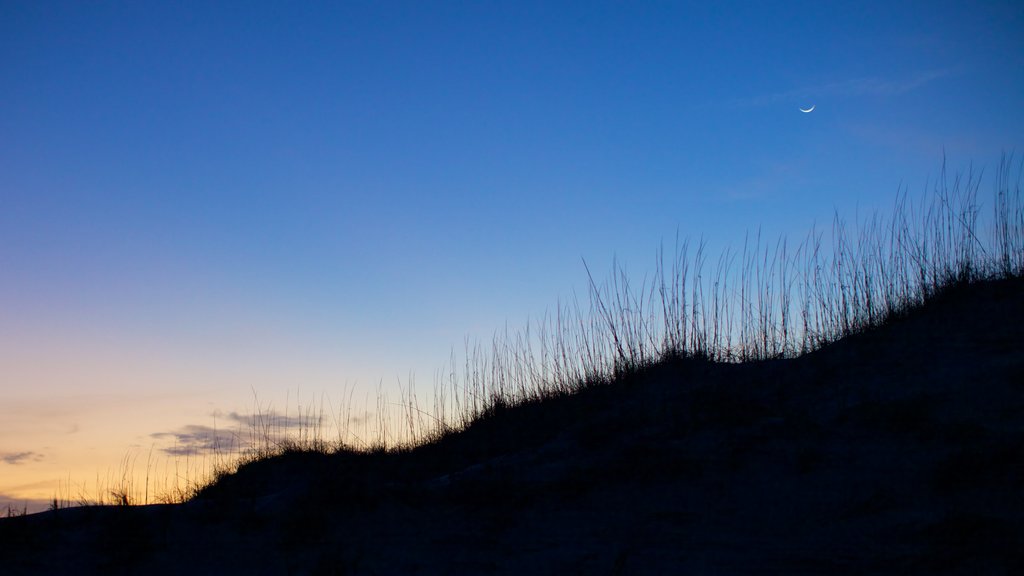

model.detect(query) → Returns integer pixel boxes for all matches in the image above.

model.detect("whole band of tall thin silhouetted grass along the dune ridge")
[44,157,1024,506]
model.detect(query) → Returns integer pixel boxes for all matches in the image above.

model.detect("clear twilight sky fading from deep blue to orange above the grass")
[0,0,1024,509]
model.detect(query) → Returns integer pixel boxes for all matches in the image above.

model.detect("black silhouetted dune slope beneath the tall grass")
[0,280,1024,575]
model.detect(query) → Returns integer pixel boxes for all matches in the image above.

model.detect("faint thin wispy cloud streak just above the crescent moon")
[732,69,954,107]
